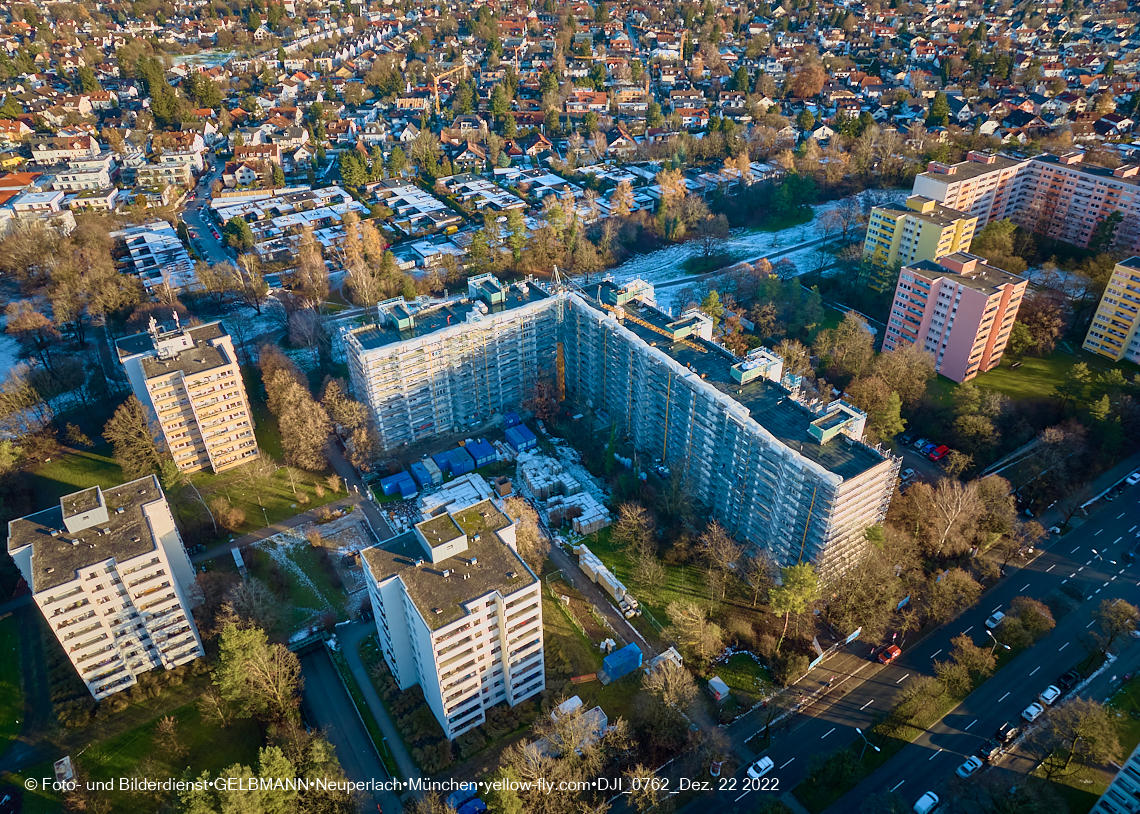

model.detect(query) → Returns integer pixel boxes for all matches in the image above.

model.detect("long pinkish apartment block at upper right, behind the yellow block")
[913,150,1140,252]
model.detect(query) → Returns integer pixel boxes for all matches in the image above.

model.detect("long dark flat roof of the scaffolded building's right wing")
[592,300,885,480]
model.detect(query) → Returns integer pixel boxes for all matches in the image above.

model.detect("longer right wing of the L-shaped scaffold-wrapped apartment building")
[561,283,899,581]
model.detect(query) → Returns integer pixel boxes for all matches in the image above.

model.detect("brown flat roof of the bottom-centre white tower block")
[360,500,528,630]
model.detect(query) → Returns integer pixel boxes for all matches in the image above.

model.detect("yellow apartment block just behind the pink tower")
[863,195,978,285]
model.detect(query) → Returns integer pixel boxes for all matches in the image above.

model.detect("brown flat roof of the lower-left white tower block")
[8,477,165,594]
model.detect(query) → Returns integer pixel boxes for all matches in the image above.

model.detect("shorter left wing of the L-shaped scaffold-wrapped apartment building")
[343,274,557,449]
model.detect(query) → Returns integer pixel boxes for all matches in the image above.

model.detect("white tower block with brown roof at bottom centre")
[361,500,546,738]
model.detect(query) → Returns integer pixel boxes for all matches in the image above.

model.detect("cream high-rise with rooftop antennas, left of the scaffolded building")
[115,315,258,472]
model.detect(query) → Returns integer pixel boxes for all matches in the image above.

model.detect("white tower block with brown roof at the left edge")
[8,475,203,700]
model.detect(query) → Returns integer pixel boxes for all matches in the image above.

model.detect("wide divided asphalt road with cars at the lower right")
[686,476,1140,814]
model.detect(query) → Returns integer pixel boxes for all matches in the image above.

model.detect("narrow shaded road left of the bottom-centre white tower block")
[301,648,402,812]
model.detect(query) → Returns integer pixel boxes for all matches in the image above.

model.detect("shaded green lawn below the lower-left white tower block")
[78,703,262,812]
